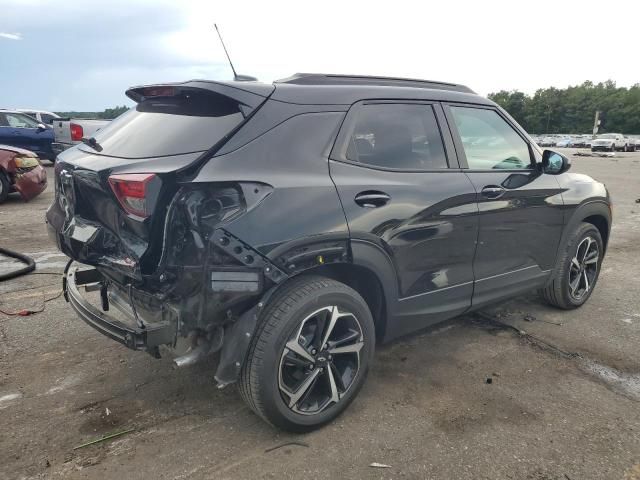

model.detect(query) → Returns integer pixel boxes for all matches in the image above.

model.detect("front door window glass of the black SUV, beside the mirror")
[451,106,531,170]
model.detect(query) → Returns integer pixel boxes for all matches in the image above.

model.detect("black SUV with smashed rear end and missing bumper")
[47,74,611,431]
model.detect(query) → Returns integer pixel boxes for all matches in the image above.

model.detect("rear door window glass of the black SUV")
[344,103,448,170]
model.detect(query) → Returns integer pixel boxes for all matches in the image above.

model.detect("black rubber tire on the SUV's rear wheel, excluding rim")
[239,276,375,432]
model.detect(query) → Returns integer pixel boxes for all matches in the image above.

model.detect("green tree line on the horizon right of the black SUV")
[489,80,640,134]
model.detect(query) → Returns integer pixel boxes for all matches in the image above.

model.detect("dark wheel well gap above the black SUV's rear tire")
[294,263,387,341]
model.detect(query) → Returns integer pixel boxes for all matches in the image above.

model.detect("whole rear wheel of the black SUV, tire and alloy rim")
[239,276,375,432]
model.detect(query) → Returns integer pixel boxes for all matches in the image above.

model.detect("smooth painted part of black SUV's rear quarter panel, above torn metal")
[194,112,348,257]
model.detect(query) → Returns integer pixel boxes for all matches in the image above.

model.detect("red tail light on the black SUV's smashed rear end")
[109,173,160,218]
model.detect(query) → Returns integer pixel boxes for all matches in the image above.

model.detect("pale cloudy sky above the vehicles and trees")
[0,0,640,111]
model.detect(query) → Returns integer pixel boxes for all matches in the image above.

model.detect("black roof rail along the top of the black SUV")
[273,73,476,93]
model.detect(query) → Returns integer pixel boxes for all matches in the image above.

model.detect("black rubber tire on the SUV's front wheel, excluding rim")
[540,223,604,310]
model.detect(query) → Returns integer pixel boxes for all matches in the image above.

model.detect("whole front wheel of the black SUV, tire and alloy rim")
[540,223,604,310]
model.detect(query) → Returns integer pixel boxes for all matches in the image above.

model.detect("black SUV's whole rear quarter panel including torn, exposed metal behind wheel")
[159,112,348,333]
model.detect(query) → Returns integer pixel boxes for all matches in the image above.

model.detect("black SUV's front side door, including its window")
[445,104,564,306]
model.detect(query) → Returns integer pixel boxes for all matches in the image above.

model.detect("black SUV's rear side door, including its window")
[329,101,478,339]
